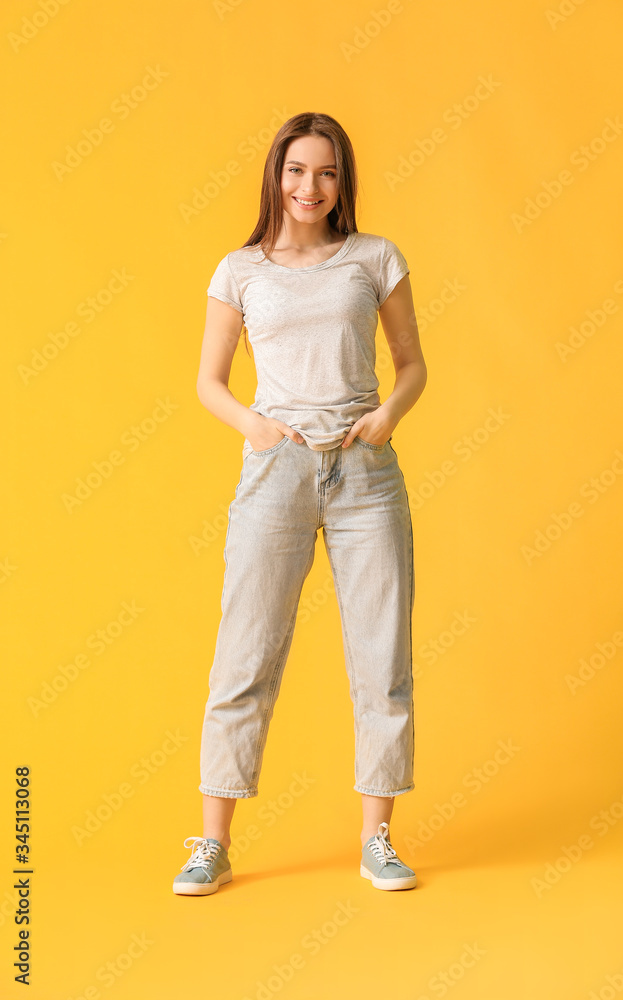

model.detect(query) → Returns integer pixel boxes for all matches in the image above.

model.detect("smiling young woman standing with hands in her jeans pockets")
[173,112,427,895]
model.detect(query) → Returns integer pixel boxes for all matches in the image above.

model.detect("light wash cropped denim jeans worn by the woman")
[199,436,415,798]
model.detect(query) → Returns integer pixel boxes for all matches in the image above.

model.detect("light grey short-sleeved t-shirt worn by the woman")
[207,233,409,458]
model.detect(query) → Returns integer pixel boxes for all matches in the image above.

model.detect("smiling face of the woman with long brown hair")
[281,135,337,223]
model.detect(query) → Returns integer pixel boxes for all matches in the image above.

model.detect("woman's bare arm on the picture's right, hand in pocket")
[342,274,428,447]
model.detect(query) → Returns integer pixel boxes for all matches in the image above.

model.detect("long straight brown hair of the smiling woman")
[239,111,357,354]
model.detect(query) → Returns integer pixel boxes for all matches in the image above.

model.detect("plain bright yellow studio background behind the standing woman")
[0,0,623,1000]
